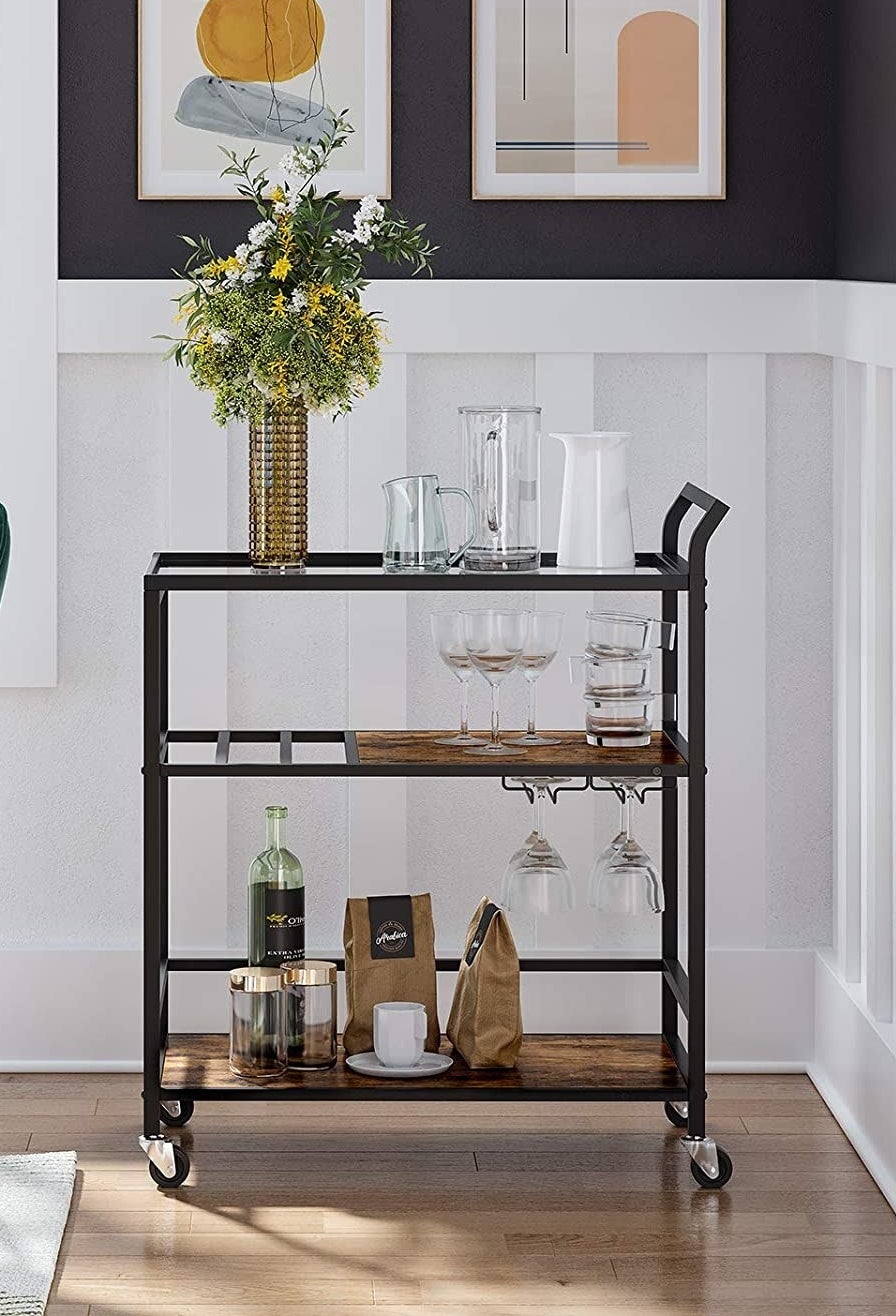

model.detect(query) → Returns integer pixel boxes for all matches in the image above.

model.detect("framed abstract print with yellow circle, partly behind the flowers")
[138,0,391,199]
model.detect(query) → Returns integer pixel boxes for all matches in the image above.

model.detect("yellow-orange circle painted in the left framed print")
[196,0,324,83]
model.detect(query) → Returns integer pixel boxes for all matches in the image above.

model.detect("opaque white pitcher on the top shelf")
[551,430,634,571]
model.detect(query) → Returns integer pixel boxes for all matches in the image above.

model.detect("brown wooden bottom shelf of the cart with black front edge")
[162,1033,687,1101]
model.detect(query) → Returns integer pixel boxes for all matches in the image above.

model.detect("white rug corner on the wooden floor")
[0,1152,78,1316]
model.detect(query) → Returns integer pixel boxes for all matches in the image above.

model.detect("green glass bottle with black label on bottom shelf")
[249,805,305,965]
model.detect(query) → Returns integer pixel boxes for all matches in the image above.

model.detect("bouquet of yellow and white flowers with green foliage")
[168,114,436,425]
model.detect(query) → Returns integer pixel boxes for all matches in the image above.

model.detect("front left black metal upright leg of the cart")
[143,590,167,1137]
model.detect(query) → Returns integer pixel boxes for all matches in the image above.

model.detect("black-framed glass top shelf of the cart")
[143,553,689,592]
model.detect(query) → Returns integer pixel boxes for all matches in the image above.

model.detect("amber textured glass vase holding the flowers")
[249,401,308,569]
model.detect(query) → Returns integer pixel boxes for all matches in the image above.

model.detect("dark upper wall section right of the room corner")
[837,0,896,282]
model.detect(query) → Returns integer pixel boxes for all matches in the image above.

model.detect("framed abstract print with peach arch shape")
[472,0,725,200]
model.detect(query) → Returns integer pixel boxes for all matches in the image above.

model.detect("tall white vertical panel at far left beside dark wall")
[0,4,58,687]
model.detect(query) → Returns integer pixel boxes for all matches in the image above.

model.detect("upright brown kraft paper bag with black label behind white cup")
[342,894,442,1055]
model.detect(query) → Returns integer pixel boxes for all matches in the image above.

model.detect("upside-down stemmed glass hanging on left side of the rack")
[501,776,575,945]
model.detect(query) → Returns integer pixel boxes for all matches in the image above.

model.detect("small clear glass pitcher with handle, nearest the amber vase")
[383,475,474,574]
